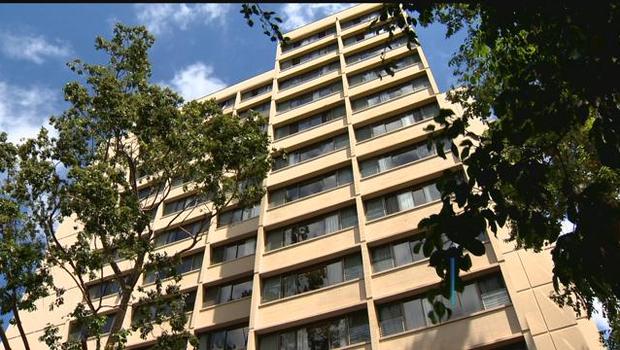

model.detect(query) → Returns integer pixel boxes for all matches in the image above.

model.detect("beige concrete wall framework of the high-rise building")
[8,4,600,350]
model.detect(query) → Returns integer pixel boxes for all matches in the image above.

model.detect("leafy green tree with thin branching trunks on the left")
[0,24,271,350]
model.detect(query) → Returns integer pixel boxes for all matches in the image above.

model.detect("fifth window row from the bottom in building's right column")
[355,103,439,142]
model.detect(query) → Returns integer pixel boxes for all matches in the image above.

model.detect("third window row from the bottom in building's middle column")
[265,207,357,251]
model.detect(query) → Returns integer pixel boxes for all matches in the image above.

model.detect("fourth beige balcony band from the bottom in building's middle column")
[267,148,351,187]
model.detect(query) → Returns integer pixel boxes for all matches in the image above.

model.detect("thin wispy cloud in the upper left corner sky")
[0,32,72,64]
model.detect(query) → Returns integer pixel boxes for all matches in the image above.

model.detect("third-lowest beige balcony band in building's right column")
[365,201,442,242]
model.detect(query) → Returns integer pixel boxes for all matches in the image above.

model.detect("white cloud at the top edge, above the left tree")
[135,4,231,34]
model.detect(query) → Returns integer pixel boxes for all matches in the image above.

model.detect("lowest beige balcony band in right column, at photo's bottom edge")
[379,305,521,350]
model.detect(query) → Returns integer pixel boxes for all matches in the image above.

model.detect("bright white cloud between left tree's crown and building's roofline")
[162,62,227,101]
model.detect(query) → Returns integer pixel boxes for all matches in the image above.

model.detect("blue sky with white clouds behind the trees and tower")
[0,4,462,141]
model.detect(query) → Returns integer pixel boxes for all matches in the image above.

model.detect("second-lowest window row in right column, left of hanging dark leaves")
[370,238,425,272]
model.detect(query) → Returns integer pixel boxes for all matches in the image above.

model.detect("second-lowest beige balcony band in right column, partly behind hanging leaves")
[372,242,497,299]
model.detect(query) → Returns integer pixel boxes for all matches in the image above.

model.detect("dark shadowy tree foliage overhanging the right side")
[246,1,620,344]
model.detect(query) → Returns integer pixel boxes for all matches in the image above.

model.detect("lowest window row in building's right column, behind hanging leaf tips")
[378,275,510,336]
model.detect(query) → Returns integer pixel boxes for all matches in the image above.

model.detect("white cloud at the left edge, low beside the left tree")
[0,81,59,142]
